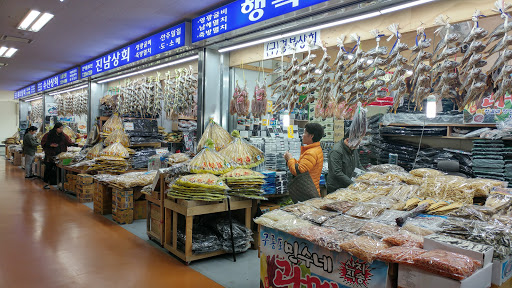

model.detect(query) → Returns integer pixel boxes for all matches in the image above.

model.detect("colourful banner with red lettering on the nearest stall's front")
[260,226,388,288]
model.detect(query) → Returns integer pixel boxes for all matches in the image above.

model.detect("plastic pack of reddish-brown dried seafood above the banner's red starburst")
[340,236,389,263]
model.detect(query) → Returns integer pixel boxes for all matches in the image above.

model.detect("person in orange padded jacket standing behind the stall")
[284,123,324,197]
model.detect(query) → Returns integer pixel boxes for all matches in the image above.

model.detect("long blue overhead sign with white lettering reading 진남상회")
[80,22,187,78]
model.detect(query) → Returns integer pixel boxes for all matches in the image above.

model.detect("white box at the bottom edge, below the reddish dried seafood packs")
[398,264,493,288]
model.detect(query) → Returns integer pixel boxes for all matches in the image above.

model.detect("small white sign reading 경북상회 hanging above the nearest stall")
[263,30,320,60]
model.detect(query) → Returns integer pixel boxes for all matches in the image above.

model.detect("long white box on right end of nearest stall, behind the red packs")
[423,234,494,266]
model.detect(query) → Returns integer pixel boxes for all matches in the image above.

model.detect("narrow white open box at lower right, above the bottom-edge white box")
[423,234,494,266]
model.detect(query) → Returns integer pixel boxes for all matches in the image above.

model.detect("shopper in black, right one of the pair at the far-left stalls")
[41,122,73,189]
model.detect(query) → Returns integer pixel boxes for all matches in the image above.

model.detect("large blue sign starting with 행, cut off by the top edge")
[192,0,328,42]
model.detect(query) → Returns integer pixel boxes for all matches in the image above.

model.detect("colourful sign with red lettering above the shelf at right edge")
[464,94,512,124]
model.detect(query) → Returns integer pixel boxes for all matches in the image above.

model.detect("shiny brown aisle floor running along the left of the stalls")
[0,159,222,288]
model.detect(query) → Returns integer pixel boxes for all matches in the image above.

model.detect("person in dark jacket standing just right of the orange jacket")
[326,133,363,193]
